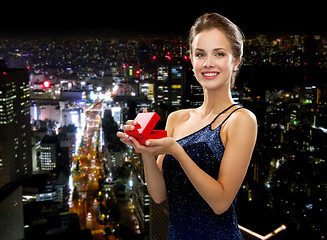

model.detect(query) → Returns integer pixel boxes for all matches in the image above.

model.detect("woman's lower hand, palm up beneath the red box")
[129,137,181,156]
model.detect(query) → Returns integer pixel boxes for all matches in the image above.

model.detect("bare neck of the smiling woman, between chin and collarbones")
[199,85,234,115]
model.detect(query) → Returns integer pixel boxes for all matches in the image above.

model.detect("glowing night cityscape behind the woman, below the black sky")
[0,30,327,240]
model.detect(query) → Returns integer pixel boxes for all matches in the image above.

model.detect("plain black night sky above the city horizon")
[0,1,327,37]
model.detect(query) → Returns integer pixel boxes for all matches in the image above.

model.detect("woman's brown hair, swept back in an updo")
[189,13,244,86]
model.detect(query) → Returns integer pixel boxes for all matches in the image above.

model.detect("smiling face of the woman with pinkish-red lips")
[191,28,240,90]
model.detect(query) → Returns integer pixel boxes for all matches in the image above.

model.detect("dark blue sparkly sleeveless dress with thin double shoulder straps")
[162,104,243,240]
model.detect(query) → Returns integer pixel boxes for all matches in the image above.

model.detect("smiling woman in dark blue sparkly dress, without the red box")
[117,13,257,240]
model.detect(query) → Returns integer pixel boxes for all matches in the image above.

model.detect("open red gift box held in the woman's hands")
[126,112,167,145]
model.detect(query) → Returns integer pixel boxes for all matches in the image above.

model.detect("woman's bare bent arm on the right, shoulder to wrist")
[174,111,257,214]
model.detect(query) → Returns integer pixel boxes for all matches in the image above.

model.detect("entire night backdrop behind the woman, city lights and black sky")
[0,1,327,240]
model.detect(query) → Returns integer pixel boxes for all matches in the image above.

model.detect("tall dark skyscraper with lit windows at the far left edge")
[0,60,32,188]
